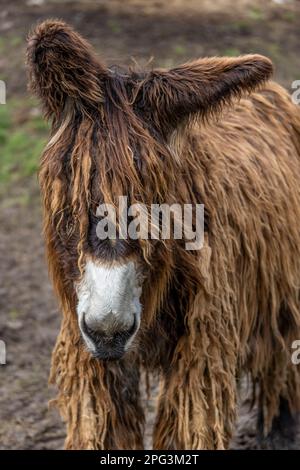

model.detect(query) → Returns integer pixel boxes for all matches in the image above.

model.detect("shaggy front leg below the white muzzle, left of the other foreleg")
[50,320,144,450]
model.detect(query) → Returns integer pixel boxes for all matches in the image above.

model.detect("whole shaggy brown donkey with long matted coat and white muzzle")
[27,20,300,449]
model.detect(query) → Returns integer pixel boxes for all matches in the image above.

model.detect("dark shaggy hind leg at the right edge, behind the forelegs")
[257,306,300,449]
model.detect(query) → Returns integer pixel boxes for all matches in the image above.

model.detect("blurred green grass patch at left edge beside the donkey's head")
[0,103,48,192]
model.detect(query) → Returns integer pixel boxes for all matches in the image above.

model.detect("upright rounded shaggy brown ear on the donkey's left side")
[27,20,105,117]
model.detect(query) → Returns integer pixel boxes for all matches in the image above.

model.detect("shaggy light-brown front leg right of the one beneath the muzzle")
[153,338,236,449]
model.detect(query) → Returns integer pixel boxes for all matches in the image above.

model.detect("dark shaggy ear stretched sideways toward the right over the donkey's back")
[137,55,273,133]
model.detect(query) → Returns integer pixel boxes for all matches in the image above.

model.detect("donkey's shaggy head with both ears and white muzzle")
[28,21,272,359]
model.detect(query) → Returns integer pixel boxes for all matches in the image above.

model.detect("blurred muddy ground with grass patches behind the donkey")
[0,0,300,449]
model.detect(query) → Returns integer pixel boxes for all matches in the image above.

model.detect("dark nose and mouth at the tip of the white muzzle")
[81,318,137,360]
